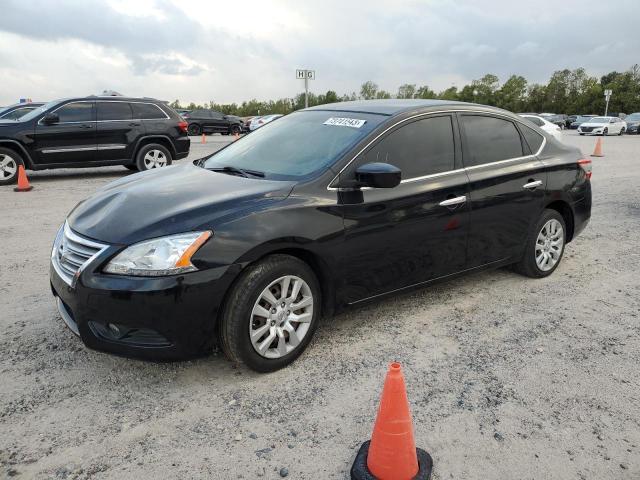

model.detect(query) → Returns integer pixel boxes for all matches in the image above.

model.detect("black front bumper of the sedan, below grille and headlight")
[49,249,240,360]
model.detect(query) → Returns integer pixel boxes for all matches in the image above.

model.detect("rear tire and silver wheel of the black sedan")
[514,209,567,278]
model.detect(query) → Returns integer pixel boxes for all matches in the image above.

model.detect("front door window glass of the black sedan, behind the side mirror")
[358,115,455,179]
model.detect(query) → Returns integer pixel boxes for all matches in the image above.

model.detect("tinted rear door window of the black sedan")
[462,115,523,167]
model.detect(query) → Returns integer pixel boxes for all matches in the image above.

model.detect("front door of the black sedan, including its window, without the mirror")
[340,114,469,302]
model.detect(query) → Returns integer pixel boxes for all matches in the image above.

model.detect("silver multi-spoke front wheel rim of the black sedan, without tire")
[249,275,313,359]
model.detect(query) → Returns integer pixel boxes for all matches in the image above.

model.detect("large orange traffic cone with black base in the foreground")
[351,362,433,480]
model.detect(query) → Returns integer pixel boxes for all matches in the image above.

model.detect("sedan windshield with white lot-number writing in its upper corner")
[202,110,388,180]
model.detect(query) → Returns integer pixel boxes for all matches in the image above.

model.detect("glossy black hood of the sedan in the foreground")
[67,163,294,245]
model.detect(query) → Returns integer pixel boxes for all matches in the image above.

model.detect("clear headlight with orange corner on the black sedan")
[104,230,212,277]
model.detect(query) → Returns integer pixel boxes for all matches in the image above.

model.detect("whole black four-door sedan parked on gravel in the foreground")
[50,100,591,372]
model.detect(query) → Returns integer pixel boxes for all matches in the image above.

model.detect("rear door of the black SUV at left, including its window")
[96,100,145,162]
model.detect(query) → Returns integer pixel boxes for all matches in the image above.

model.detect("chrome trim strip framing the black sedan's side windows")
[327,110,547,190]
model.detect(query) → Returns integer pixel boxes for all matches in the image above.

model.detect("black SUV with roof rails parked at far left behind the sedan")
[0,97,190,185]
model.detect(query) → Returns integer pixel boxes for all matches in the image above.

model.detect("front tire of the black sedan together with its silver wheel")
[220,254,322,373]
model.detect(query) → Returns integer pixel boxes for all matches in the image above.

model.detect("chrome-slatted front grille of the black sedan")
[51,223,108,287]
